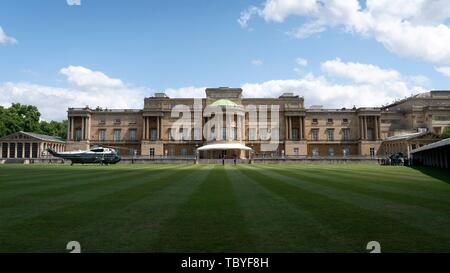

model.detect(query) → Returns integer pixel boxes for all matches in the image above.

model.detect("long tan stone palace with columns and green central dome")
[66,87,450,159]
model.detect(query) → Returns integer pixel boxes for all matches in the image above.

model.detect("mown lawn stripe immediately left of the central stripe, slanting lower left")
[73,165,213,252]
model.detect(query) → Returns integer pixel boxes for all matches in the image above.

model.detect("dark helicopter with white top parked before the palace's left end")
[47,147,121,165]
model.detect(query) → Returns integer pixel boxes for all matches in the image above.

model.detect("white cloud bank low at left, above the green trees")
[0,66,149,120]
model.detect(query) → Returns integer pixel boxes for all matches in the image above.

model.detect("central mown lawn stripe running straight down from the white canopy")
[156,166,254,252]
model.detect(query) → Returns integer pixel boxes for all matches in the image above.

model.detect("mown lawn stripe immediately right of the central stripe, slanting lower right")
[227,164,348,252]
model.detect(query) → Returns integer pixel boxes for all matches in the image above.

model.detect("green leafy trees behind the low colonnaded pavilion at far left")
[0,103,67,139]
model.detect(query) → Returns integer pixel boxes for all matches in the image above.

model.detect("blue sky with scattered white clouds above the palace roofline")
[0,0,450,119]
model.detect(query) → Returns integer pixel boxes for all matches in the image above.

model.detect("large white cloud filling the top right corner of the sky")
[241,0,450,64]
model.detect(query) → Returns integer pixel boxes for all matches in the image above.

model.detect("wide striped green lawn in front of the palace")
[0,165,450,252]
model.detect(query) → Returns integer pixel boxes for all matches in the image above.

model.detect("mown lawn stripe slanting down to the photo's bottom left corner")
[0,165,197,252]
